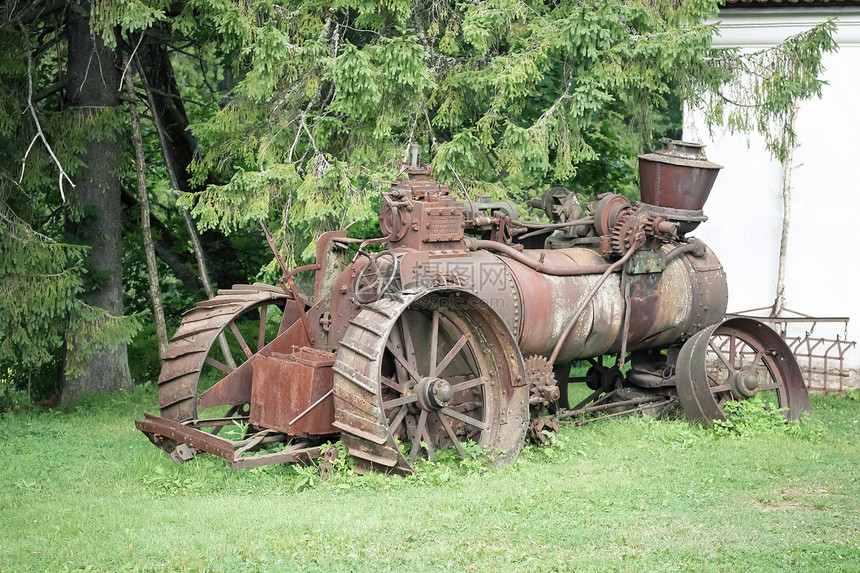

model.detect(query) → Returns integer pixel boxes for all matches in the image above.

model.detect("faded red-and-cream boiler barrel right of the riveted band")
[503,242,728,363]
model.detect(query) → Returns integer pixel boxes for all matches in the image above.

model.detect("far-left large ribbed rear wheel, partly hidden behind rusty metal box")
[158,283,288,422]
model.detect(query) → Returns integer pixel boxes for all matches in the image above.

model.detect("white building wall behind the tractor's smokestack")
[684,7,860,376]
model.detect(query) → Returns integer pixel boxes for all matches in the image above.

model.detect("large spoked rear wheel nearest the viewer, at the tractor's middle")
[334,289,528,475]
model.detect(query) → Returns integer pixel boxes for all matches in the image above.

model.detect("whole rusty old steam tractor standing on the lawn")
[137,140,809,474]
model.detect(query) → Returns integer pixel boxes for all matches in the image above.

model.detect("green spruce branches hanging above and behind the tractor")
[174,0,833,259]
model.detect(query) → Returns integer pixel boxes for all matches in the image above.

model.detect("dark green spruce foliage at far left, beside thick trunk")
[0,11,151,399]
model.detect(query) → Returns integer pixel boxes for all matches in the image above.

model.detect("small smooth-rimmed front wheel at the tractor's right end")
[676,318,810,425]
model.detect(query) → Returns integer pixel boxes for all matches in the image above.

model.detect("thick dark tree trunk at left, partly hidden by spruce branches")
[61,0,134,403]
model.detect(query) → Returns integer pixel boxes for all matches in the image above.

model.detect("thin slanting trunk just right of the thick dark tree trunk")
[125,69,167,358]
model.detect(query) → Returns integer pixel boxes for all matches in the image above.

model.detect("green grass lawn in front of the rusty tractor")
[0,388,860,572]
